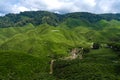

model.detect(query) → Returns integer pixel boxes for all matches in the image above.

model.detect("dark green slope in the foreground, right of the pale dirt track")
[54,49,120,80]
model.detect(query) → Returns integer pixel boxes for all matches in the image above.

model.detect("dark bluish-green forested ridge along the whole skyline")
[0,11,120,27]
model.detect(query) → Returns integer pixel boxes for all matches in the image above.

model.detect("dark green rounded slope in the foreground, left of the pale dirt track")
[0,51,55,80]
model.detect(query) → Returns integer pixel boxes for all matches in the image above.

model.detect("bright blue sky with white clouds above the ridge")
[0,0,120,16]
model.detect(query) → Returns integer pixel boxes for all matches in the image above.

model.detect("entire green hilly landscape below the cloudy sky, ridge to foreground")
[0,11,120,80]
